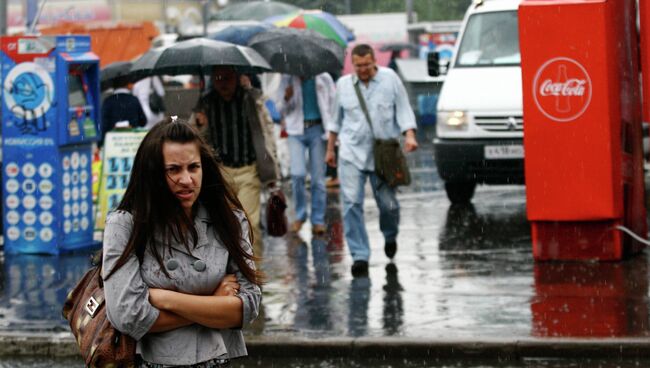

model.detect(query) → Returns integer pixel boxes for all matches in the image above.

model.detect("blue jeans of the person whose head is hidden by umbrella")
[289,124,327,225]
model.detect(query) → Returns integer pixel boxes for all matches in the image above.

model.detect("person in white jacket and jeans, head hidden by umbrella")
[276,73,336,235]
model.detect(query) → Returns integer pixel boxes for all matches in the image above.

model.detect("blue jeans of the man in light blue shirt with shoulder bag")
[338,159,399,261]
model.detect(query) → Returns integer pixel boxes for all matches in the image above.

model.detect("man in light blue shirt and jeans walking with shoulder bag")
[325,44,418,276]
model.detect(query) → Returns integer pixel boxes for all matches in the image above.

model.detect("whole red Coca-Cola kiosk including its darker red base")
[519,0,647,260]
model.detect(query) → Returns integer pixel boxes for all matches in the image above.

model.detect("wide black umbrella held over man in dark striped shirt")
[152,38,271,75]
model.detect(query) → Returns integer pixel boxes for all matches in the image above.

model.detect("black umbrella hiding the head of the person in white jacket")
[248,28,345,77]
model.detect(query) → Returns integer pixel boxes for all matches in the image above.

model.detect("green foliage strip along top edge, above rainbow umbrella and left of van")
[282,0,472,21]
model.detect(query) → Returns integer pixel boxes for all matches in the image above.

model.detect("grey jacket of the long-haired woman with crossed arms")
[103,206,261,365]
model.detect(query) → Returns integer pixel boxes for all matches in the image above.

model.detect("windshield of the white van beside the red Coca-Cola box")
[456,11,521,67]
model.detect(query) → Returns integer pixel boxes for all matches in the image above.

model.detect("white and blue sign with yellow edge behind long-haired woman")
[95,130,147,230]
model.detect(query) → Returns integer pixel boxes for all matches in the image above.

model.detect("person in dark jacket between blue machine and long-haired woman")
[98,78,147,147]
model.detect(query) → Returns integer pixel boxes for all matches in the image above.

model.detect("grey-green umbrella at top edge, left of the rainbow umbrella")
[210,1,300,21]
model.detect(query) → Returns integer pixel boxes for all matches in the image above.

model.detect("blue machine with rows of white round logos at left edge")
[0,35,100,254]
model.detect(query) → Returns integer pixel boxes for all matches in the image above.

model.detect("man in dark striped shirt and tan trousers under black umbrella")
[190,66,278,257]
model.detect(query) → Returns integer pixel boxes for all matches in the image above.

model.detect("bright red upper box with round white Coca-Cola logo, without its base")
[519,1,623,220]
